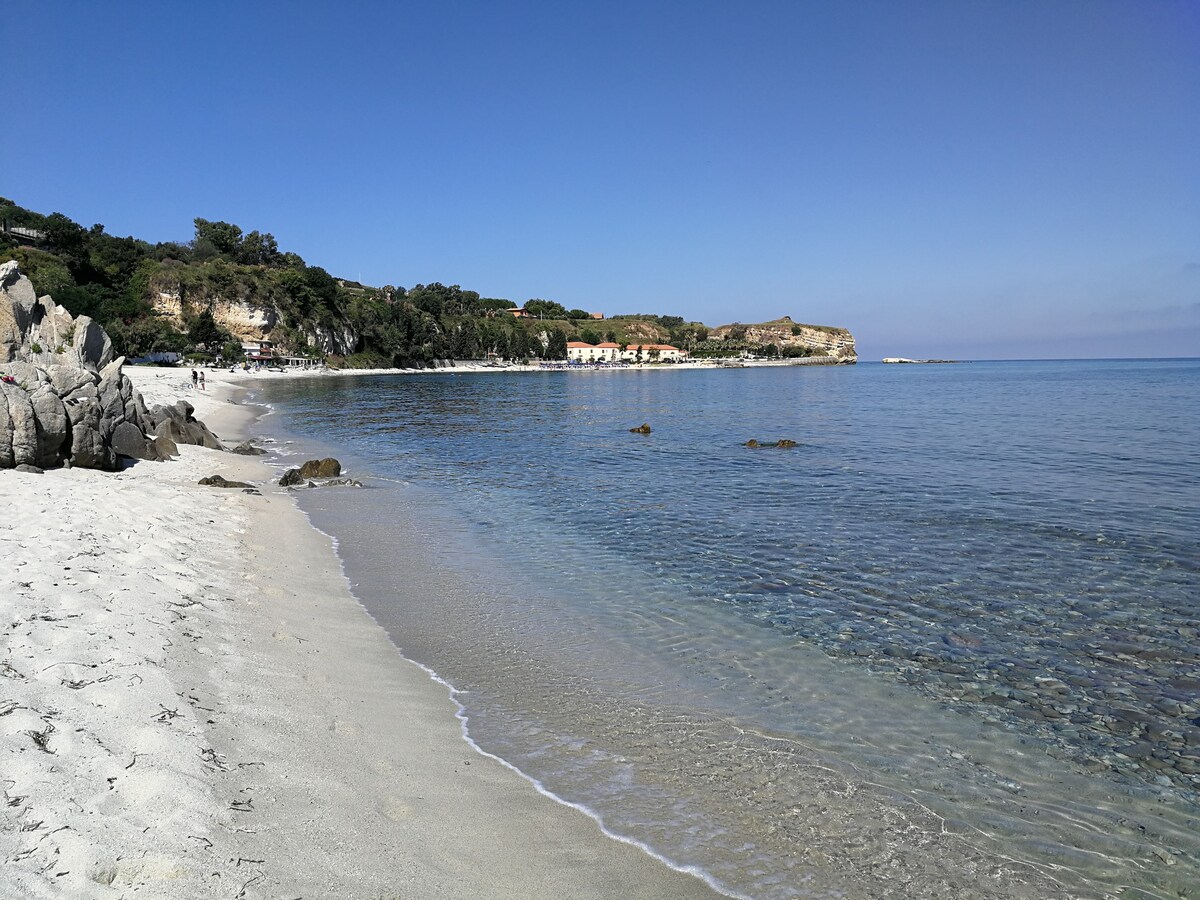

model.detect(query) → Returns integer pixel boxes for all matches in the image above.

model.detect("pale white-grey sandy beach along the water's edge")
[0,368,716,900]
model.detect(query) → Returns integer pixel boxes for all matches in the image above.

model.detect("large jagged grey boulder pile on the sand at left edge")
[0,262,168,469]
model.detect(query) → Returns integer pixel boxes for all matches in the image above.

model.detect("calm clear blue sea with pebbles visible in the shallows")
[250,360,1200,898]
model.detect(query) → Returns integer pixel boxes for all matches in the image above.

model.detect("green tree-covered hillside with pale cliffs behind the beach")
[0,198,852,367]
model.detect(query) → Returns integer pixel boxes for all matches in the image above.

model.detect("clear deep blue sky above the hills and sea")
[0,0,1200,359]
